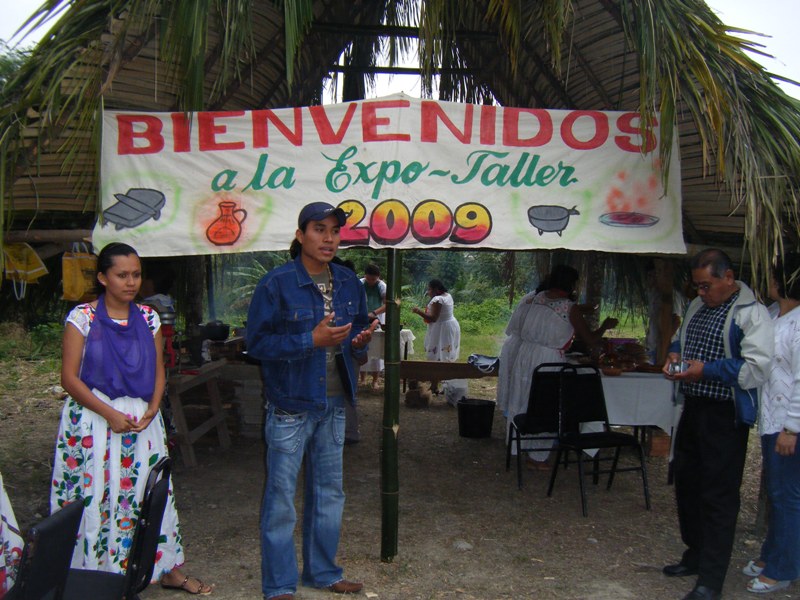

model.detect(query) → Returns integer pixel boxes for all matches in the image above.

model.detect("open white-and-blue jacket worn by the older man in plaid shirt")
[669,281,775,426]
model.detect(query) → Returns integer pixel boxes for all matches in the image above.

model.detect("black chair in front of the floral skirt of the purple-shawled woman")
[64,456,171,600]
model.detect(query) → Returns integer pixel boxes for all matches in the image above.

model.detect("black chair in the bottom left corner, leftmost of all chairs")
[5,501,83,600]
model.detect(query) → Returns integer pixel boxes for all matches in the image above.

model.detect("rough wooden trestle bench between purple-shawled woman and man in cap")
[167,359,231,467]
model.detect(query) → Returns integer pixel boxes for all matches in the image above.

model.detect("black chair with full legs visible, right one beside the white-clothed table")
[547,365,650,517]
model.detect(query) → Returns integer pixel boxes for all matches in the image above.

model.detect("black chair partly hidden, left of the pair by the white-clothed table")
[506,363,568,489]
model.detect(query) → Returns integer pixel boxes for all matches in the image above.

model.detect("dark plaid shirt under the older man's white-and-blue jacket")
[681,292,739,400]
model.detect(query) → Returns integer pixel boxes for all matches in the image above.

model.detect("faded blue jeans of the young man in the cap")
[261,397,345,598]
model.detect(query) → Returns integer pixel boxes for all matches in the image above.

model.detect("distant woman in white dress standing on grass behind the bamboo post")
[411,279,461,391]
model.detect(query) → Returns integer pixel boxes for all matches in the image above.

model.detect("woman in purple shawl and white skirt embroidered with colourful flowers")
[50,243,213,595]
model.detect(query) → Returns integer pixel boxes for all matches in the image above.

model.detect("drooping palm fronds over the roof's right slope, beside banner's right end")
[620,0,800,282]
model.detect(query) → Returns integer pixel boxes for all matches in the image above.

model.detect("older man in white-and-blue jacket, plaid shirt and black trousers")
[663,248,774,600]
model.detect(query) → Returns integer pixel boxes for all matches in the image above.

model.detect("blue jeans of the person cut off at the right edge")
[761,433,800,581]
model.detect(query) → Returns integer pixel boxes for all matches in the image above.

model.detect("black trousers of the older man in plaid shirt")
[674,396,750,591]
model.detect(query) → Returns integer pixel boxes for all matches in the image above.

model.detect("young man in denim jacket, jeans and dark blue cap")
[247,202,372,600]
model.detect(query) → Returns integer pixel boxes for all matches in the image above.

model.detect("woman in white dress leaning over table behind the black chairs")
[497,265,617,468]
